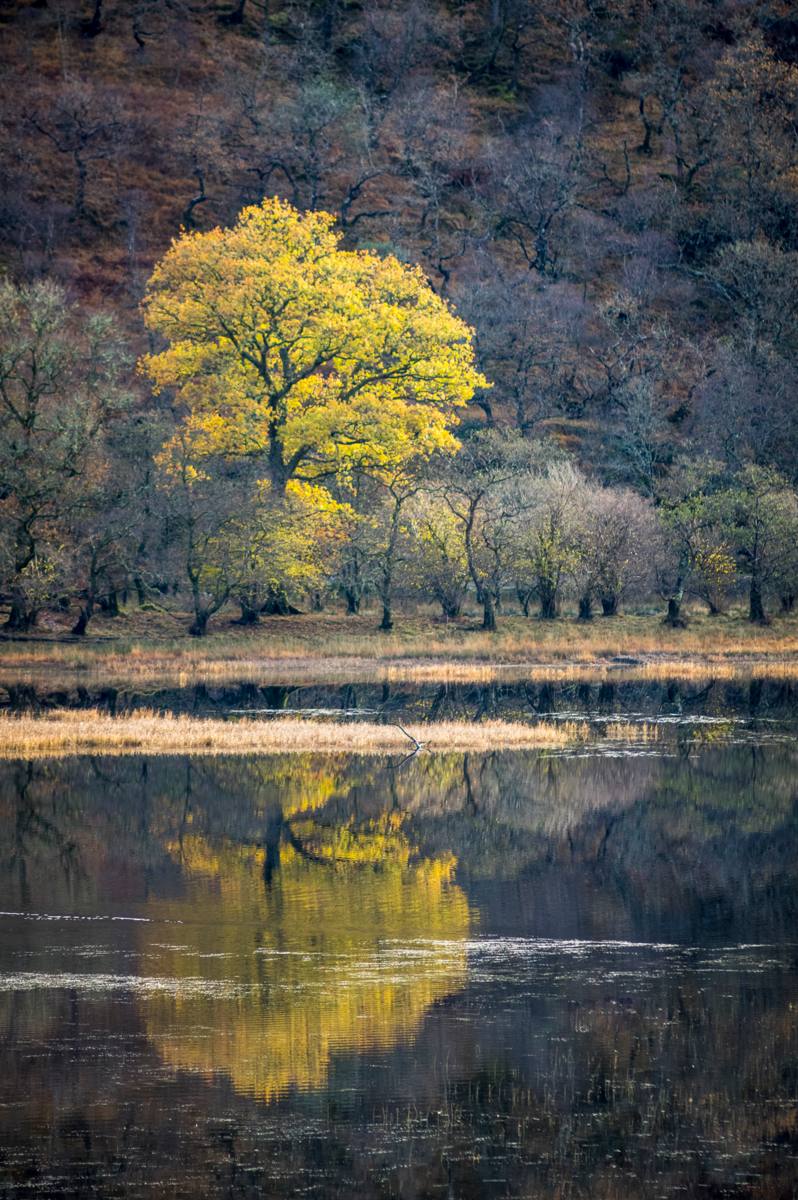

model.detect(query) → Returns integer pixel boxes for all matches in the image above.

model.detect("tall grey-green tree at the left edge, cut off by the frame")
[0,282,128,630]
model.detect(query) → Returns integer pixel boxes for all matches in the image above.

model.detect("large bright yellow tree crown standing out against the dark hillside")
[142,199,487,494]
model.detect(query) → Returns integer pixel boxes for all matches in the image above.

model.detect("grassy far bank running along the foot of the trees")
[0,610,798,684]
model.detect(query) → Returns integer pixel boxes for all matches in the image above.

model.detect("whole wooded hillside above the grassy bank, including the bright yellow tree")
[0,0,798,635]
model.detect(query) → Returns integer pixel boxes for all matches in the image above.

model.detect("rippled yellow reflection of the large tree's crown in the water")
[145,817,469,1100]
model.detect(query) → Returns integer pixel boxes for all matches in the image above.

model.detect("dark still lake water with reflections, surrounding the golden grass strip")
[0,683,798,1200]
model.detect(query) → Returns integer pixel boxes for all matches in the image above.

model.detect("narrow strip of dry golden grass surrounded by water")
[0,709,588,758]
